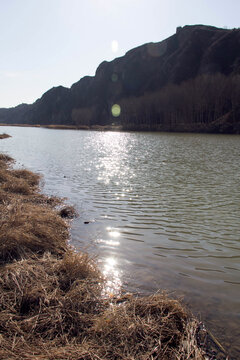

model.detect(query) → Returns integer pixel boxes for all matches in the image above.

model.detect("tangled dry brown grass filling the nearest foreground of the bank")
[0,251,201,360]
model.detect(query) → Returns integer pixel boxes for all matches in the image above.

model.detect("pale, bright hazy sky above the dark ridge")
[0,0,240,108]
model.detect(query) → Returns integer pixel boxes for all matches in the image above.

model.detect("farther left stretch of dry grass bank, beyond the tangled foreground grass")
[0,156,69,263]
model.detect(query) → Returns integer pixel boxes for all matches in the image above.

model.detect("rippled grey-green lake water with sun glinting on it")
[0,127,240,359]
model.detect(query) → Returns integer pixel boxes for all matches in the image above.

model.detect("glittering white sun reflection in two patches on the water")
[92,132,135,297]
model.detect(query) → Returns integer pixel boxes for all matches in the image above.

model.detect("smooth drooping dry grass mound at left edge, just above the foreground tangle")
[0,201,69,262]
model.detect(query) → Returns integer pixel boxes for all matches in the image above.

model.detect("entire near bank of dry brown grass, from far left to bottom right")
[0,134,229,360]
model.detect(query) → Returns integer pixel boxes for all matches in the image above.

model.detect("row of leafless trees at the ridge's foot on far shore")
[120,73,240,131]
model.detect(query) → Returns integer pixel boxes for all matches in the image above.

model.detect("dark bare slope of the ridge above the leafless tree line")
[0,25,240,132]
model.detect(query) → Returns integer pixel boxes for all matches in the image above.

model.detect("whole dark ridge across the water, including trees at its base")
[0,25,240,133]
